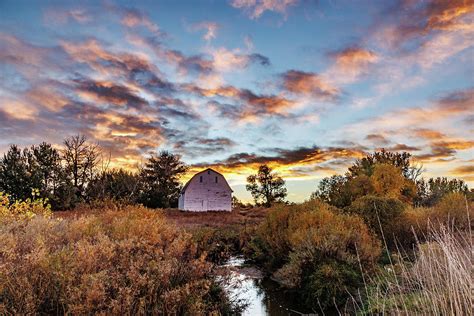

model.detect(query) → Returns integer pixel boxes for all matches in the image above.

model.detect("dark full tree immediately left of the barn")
[140,151,188,208]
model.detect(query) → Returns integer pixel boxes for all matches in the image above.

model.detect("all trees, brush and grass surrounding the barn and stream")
[0,141,474,315]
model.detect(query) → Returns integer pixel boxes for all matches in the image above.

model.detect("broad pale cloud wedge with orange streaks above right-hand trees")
[341,88,474,163]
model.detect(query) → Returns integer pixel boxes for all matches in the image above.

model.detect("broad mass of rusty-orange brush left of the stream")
[0,207,235,315]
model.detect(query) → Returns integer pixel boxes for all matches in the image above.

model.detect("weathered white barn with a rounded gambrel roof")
[178,168,233,212]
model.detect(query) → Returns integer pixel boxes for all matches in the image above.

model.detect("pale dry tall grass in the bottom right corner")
[359,214,473,315]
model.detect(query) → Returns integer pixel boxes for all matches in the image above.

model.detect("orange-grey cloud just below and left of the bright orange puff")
[281,70,341,101]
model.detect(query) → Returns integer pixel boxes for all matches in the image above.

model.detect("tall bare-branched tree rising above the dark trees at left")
[63,135,101,197]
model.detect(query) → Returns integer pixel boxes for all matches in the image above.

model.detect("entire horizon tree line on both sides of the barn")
[0,135,472,210]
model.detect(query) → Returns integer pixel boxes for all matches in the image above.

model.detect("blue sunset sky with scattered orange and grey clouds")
[0,0,474,201]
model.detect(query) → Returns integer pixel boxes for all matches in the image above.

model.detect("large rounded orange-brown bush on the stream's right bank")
[244,200,380,308]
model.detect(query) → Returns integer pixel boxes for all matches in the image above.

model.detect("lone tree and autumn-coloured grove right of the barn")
[246,149,474,208]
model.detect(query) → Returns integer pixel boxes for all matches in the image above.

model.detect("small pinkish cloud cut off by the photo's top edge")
[231,0,298,19]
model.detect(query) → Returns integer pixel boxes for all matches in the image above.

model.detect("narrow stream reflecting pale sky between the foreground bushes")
[223,257,316,316]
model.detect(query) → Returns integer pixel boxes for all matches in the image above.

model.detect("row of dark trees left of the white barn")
[0,135,188,210]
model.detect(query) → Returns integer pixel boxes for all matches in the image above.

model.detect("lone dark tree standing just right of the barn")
[246,165,287,207]
